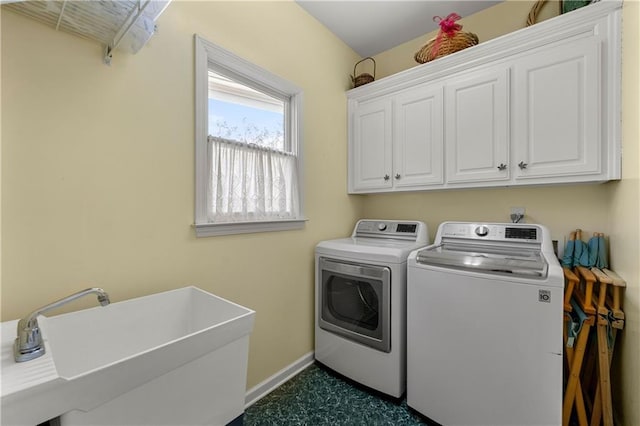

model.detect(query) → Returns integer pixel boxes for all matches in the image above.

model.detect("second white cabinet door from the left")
[393,87,444,188]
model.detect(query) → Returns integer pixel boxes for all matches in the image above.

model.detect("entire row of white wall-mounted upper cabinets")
[347,0,622,193]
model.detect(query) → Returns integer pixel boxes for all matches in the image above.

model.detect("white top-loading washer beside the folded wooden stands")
[407,222,564,426]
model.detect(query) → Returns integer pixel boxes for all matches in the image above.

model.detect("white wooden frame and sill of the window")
[194,34,307,237]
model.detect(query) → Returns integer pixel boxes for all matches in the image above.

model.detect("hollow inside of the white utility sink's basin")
[41,287,251,379]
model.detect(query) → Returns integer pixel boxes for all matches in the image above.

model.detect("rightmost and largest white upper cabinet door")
[514,38,602,181]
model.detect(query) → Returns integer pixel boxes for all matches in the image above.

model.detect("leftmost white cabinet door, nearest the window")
[349,98,393,192]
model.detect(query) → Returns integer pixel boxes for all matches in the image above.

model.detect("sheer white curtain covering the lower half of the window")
[207,136,299,223]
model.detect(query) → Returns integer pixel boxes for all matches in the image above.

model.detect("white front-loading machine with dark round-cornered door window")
[315,220,429,398]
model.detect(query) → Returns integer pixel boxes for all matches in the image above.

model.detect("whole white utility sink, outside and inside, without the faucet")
[2,287,255,425]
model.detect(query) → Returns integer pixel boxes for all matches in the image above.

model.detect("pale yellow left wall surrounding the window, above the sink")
[2,1,361,387]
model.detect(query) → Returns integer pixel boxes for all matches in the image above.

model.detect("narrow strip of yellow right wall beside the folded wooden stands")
[607,0,640,425]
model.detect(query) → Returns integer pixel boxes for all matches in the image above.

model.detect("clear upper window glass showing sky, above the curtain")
[208,70,286,151]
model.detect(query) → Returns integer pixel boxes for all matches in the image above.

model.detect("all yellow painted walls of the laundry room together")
[0,1,640,425]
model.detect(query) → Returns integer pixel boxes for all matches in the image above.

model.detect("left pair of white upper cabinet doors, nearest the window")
[349,87,443,192]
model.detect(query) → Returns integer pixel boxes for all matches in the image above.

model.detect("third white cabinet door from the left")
[445,67,509,183]
